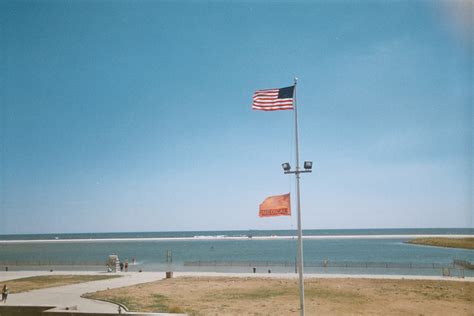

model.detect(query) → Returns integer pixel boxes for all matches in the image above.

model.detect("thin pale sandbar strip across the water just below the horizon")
[0,234,474,244]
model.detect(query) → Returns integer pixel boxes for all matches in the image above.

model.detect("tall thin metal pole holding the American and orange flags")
[293,78,304,316]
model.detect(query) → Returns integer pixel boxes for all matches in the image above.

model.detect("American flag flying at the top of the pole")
[252,86,295,111]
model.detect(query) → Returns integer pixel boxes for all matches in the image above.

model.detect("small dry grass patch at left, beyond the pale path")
[1,275,120,294]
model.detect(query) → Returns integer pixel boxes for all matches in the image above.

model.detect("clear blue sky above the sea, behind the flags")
[0,0,474,234]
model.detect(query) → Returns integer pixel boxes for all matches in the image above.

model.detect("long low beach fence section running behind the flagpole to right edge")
[184,260,474,277]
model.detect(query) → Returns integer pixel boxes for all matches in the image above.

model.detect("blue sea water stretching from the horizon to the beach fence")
[0,229,474,276]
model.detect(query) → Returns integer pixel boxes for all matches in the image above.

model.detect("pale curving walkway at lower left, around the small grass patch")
[0,271,174,315]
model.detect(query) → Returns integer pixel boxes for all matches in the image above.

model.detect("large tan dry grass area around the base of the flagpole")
[85,277,474,316]
